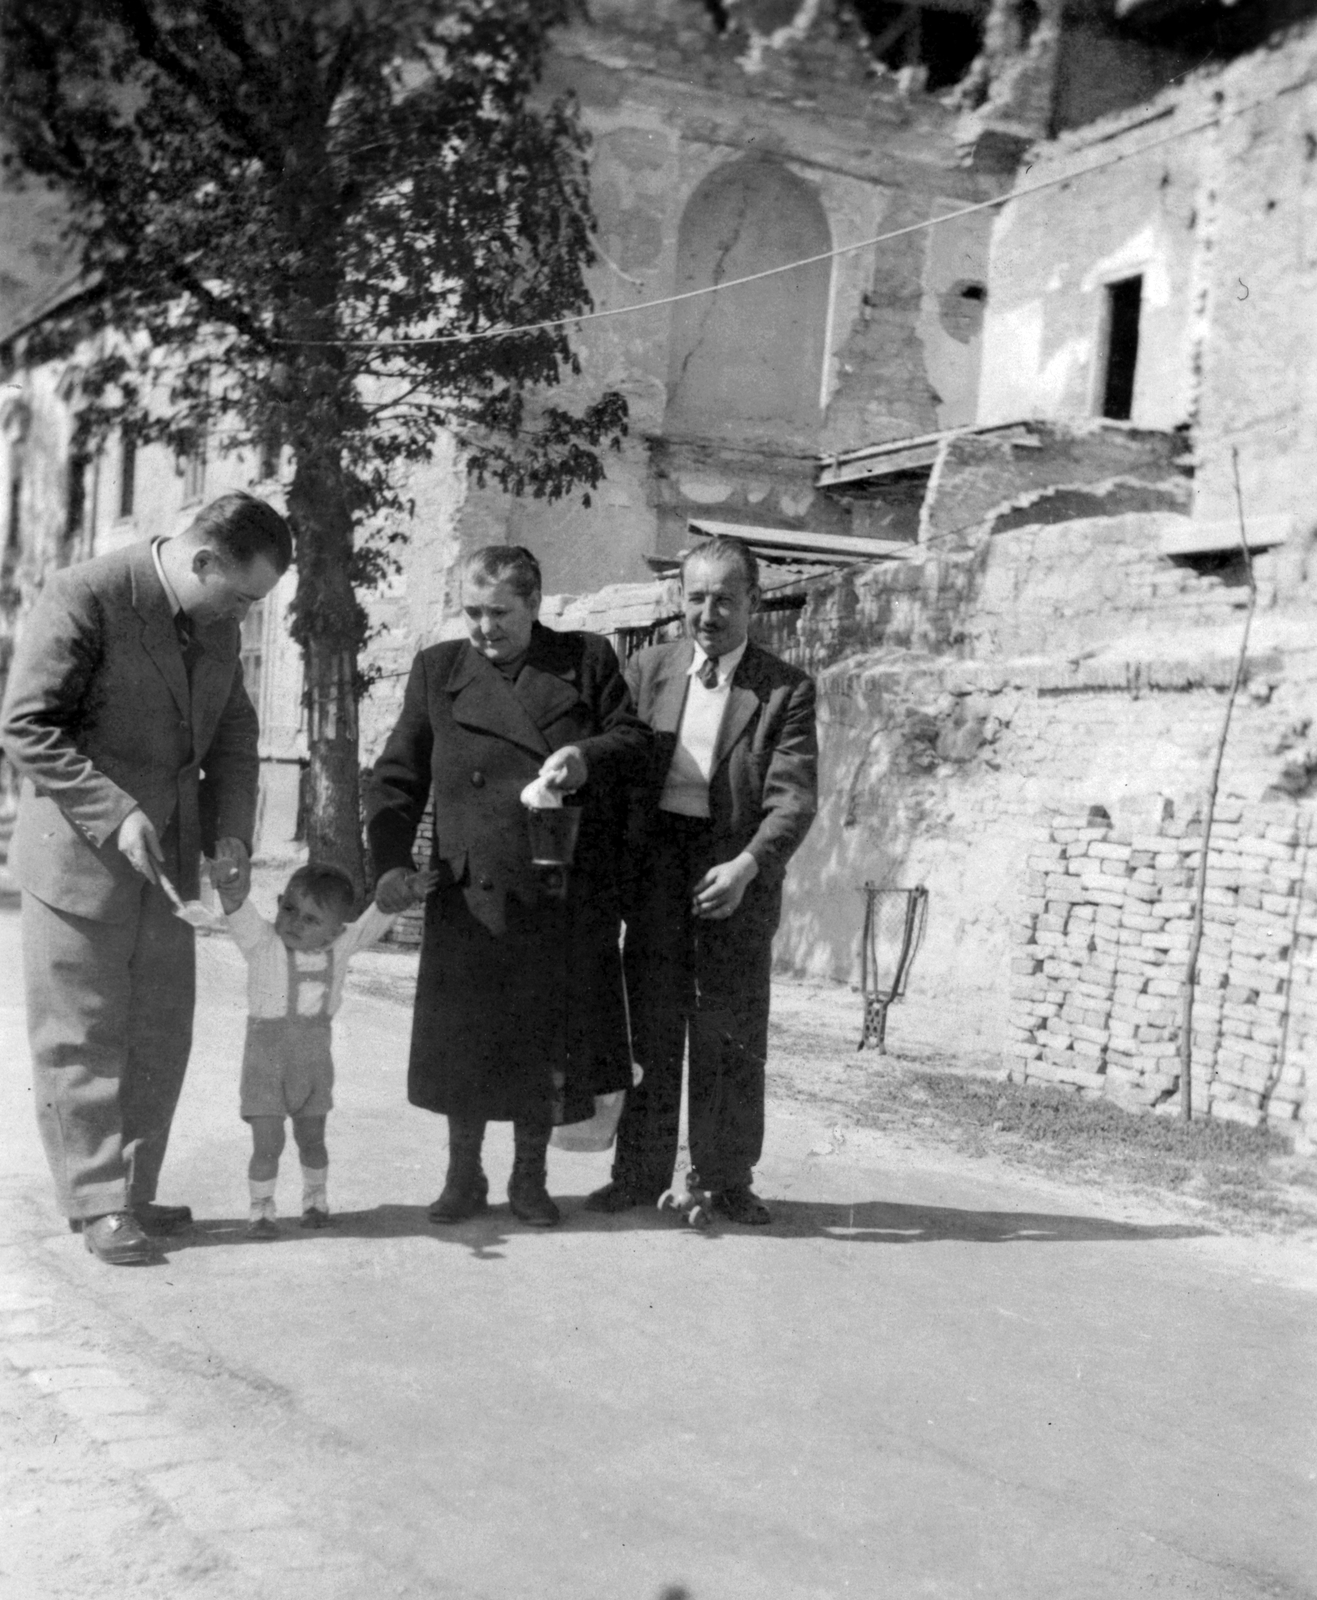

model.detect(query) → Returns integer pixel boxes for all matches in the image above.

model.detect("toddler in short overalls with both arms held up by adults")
[218,862,429,1238]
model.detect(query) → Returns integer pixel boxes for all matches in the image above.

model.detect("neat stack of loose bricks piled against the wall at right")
[1005,798,1317,1144]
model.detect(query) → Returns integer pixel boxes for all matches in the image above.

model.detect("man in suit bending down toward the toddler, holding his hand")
[0,494,291,1264]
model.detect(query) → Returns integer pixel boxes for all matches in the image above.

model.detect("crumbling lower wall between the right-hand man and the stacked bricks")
[778,478,1317,1051]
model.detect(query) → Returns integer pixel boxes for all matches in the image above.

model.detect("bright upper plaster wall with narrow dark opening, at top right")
[978,27,1317,522]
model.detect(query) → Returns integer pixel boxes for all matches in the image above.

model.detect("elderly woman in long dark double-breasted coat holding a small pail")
[366,546,650,1227]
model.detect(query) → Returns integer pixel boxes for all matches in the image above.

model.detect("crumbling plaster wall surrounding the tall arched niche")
[435,0,989,592]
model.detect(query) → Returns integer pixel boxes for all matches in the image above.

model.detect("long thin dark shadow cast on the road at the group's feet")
[163,1198,1211,1259]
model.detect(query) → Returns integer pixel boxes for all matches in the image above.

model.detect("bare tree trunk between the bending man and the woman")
[288,454,365,893]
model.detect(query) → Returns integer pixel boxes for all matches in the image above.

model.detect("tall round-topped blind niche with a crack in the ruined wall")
[664,157,832,443]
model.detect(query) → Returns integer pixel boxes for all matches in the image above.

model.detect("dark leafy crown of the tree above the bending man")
[0,0,626,876]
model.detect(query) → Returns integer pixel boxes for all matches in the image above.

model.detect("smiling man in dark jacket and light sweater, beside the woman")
[586,539,818,1222]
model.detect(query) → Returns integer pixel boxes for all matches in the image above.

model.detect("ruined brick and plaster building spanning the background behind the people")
[0,0,1317,1130]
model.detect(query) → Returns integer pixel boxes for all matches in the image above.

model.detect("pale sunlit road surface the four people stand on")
[0,909,1317,1600]
